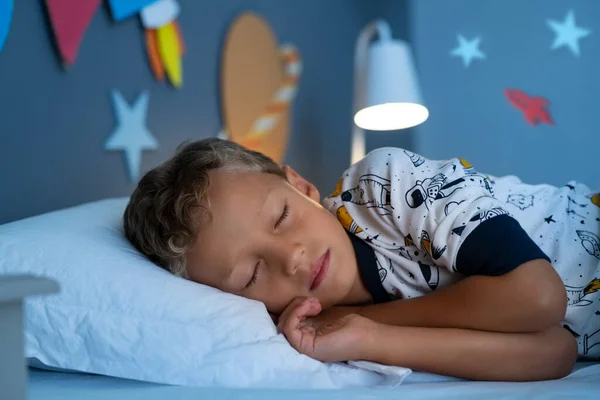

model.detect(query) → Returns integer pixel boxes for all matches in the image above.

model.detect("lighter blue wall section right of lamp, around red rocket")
[409,0,600,188]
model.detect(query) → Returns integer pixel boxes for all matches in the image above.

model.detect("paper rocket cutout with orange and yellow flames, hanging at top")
[140,0,185,87]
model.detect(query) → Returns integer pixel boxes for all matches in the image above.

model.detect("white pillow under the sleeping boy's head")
[0,198,390,388]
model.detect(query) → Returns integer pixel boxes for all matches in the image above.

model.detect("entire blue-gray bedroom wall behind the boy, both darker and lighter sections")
[9,0,584,223]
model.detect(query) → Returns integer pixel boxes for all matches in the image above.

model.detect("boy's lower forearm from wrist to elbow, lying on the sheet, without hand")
[364,324,577,381]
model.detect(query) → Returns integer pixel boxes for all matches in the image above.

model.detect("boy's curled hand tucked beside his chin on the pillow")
[277,297,377,362]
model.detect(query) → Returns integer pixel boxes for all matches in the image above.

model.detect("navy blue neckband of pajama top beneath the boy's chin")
[346,231,393,303]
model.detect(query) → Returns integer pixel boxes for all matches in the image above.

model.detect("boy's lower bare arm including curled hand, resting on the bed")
[278,298,577,381]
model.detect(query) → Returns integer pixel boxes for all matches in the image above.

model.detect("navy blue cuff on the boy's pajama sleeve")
[456,215,550,276]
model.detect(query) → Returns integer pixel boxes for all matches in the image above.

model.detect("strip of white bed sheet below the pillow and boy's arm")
[30,363,600,400]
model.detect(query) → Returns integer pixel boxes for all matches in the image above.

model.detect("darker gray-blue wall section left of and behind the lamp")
[0,0,408,223]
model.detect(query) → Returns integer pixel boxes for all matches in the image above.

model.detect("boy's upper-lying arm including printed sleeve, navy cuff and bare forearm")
[319,149,567,332]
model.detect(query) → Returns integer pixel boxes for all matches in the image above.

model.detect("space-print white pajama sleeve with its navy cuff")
[341,148,548,276]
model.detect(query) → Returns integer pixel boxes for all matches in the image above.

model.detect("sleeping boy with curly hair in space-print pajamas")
[124,138,600,381]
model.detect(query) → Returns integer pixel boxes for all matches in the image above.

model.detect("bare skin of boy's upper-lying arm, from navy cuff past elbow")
[357,261,566,332]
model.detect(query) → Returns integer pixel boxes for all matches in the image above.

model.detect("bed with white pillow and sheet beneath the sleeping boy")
[0,199,600,400]
